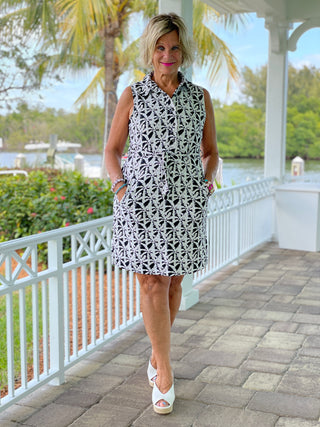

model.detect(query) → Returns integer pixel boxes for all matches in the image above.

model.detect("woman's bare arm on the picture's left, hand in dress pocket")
[105,87,133,200]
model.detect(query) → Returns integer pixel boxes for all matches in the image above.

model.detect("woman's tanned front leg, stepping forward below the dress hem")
[137,274,173,406]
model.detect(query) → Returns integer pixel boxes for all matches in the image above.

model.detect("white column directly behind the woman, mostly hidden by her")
[159,0,199,310]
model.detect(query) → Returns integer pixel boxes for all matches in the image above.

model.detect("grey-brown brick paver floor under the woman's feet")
[0,243,320,427]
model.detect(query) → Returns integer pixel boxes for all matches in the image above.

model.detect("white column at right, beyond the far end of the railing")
[264,18,288,179]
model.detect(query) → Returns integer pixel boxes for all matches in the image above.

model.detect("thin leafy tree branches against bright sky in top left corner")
[0,0,60,109]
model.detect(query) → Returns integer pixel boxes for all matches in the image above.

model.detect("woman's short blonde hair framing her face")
[140,13,193,68]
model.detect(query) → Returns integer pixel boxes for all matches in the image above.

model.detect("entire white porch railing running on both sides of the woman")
[0,179,274,411]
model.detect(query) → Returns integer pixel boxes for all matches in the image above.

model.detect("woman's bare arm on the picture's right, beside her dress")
[201,89,219,182]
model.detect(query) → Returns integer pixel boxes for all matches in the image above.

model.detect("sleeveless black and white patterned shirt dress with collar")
[112,73,208,276]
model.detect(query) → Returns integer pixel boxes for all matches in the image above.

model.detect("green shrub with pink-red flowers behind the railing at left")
[0,169,113,242]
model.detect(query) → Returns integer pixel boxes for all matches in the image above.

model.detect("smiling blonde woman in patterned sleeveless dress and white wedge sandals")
[105,13,219,414]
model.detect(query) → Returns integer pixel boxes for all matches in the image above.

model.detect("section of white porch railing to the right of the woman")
[193,178,275,285]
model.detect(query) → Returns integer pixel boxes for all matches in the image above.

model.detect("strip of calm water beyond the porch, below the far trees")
[0,151,320,187]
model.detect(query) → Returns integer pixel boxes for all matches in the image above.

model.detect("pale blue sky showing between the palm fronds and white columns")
[30,14,320,111]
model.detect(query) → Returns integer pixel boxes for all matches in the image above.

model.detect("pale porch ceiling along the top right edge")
[204,0,320,22]
